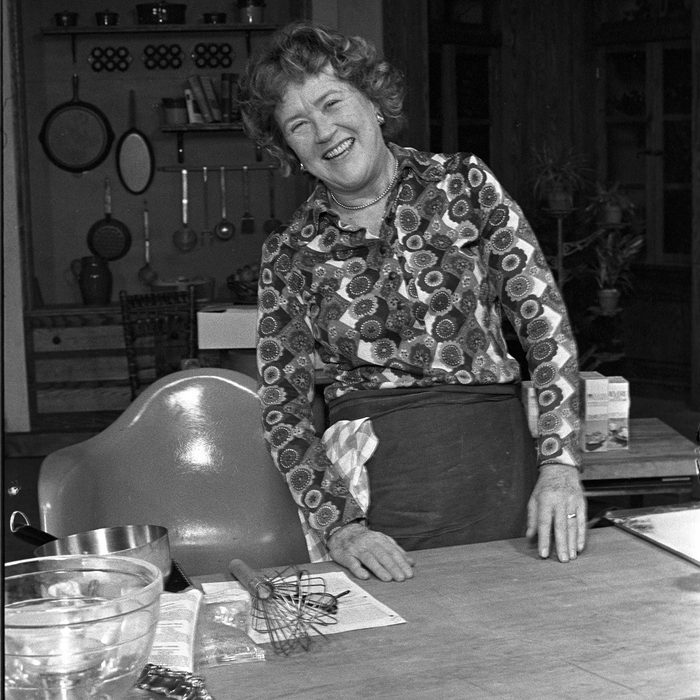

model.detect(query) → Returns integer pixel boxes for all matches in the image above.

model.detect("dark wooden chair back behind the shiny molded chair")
[119,286,199,400]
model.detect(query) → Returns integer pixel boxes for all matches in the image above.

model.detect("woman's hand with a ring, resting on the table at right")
[526,464,587,562]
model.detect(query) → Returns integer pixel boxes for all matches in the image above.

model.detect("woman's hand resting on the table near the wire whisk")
[327,522,415,581]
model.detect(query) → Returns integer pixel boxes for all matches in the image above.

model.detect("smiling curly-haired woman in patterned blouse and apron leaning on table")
[239,23,586,581]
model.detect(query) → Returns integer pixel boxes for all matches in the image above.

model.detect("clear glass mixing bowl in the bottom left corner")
[5,554,163,699]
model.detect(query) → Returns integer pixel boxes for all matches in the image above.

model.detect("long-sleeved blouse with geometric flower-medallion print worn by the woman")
[257,144,580,539]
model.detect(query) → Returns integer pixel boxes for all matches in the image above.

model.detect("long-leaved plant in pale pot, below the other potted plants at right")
[591,228,644,315]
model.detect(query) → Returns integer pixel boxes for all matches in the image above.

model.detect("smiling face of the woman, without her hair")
[275,66,388,197]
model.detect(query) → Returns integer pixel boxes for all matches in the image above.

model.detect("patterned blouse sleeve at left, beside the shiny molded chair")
[257,231,363,540]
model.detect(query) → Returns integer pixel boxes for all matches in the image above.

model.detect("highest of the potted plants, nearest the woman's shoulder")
[533,144,586,213]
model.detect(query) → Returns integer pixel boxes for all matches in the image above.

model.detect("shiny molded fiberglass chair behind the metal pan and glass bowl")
[39,368,309,575]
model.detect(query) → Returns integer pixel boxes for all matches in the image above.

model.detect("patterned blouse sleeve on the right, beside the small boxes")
[471,158,581,469]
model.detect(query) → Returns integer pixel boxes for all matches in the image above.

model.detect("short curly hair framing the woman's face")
[238,22,404,175]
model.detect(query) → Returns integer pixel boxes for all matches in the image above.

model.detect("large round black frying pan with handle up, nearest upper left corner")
[39,75,114,173]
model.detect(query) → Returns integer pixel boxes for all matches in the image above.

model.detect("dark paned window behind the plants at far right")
[601,40,692,264]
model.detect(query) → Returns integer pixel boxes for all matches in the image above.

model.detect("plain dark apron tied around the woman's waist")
[329,384,537,550]
